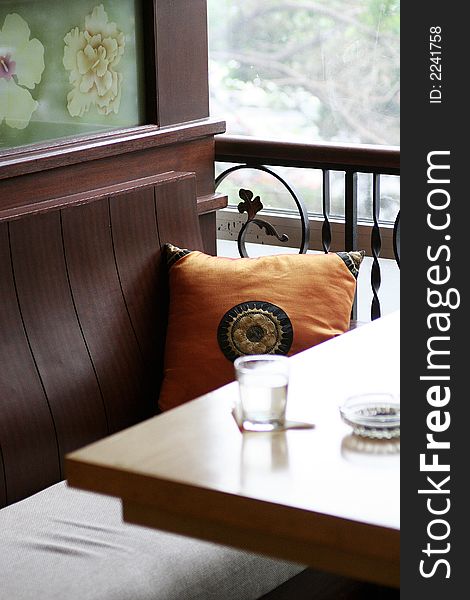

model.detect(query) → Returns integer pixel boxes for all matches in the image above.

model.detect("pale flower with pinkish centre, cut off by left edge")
[0,13,44,129]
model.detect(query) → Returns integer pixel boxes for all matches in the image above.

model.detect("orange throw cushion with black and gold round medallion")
[159,244,364,410]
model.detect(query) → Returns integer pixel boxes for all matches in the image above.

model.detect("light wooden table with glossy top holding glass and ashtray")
[66,313,399,586]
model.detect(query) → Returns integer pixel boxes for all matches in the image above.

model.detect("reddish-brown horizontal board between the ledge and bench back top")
[0,138,214,220]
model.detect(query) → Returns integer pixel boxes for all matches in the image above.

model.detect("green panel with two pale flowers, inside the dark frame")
[0,0,145,149]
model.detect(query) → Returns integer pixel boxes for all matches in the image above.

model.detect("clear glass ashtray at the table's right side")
[339,393,400,440]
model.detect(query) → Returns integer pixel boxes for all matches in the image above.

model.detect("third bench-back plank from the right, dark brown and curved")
[62,198,144,431]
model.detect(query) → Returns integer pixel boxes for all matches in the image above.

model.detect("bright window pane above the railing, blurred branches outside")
[208,0,400,145]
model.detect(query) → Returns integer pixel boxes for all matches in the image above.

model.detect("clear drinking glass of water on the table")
[234,354,289,431]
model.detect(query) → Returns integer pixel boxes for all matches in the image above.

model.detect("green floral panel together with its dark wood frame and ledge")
[0,0,218,238]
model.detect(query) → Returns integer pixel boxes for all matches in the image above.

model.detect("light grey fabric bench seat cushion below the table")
[0,483,304,600]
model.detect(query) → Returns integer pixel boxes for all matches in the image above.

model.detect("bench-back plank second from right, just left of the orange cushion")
[110,186,168,415]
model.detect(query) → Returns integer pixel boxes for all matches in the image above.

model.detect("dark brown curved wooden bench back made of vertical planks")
[0,173,202,505]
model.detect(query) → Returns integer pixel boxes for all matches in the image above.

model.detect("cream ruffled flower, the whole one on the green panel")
[63,4,125,117]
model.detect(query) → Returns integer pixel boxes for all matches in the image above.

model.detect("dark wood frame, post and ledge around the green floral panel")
[0,0,226,253]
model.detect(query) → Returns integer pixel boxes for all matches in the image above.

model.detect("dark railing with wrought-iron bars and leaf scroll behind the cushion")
[215,135,400,320]
